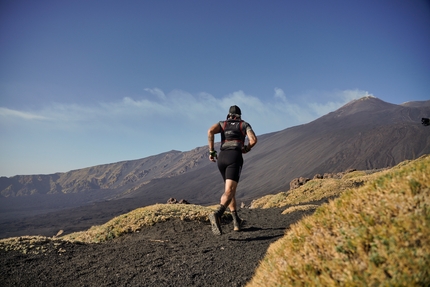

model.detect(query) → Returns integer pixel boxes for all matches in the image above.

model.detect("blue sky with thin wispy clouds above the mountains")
[0,0,430,176]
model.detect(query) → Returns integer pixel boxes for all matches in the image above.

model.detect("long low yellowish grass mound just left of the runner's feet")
[62,204,220,243]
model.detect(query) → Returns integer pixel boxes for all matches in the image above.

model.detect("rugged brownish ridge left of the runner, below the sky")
[0,147,211,197]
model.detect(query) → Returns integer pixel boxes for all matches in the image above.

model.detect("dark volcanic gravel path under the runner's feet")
[0,209,316,287]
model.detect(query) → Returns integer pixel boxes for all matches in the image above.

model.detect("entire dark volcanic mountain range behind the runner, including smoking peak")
[0,97,430,236]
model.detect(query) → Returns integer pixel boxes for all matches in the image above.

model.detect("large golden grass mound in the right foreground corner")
[247,155,430,287]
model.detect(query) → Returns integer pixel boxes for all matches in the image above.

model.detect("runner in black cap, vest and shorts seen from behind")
[208,106,257,235]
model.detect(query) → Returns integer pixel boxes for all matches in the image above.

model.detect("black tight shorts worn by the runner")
[218,150,243,182]
